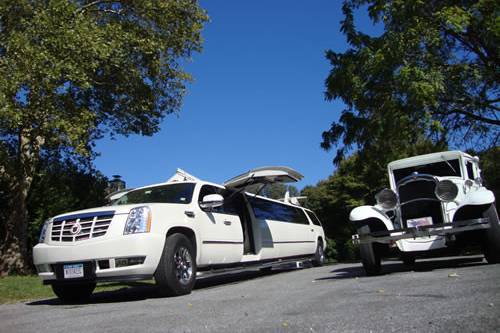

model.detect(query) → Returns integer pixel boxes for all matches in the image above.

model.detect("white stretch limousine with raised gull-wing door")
[33,167,326,301]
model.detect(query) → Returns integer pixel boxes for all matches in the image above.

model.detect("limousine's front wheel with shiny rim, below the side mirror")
[155,233,196,296]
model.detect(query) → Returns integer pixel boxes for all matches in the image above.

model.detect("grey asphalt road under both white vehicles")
[0,257,500,333]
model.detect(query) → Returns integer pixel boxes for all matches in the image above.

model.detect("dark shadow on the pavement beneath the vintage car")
[316,256,486,281]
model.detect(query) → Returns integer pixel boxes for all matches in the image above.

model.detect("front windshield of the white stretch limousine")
[114,183,195,205]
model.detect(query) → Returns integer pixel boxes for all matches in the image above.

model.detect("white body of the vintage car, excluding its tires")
[350,151,496,253]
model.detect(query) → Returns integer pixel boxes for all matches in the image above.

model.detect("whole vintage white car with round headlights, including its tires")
[350,151,500,275]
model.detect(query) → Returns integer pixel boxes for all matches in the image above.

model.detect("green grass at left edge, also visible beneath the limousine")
[0,275,153,304]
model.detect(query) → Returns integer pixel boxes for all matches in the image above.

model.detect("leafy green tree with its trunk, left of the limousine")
[0,0,207,274]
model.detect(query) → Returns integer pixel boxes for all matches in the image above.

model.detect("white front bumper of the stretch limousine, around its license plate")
[33,233,165,284]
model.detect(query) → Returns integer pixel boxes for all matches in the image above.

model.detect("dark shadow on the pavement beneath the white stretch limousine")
[26,268,291,308]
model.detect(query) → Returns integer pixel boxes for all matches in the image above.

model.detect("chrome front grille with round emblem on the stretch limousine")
[51,211,115,242]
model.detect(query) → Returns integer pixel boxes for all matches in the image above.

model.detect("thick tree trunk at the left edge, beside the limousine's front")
[0,130,43,276]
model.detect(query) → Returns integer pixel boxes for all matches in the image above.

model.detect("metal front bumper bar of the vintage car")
[352,218,490,244]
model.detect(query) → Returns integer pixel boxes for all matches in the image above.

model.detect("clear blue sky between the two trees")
[95,0,374,188]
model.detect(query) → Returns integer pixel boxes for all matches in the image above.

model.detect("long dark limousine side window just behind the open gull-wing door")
[249,197,309,224]
